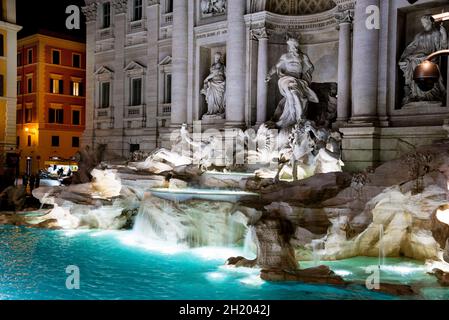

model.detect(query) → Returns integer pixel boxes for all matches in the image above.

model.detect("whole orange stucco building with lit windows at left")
[17,34,86,174]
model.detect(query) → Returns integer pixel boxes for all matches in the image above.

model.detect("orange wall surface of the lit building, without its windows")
[17,34,87,173]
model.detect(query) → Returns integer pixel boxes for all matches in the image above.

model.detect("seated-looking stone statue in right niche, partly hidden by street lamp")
[399,15,448,105]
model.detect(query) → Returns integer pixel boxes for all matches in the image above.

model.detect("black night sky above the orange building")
[17,0,86,41]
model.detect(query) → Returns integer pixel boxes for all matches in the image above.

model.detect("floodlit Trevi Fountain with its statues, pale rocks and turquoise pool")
[0,1,449,300]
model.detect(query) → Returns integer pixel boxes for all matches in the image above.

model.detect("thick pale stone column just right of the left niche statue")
[226,0,246,127]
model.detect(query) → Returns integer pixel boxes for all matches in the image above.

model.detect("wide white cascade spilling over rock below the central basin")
[133,196,247,248]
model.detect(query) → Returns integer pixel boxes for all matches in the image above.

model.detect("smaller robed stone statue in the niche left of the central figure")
[201,52,226,119]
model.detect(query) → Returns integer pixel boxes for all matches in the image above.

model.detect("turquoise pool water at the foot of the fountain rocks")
[0,227,449,300]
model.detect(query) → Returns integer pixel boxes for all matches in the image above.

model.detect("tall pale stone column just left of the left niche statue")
[171,0,188,128]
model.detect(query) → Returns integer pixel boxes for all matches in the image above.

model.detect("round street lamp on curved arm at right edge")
[413,50,449,92]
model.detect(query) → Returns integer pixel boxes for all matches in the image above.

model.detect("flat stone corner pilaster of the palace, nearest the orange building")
[81,2,97,147]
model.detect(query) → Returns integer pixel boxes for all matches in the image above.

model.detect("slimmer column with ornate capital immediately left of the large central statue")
[253,28,268,125]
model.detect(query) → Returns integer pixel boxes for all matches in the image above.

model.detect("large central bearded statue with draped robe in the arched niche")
[266,38,319,128]
